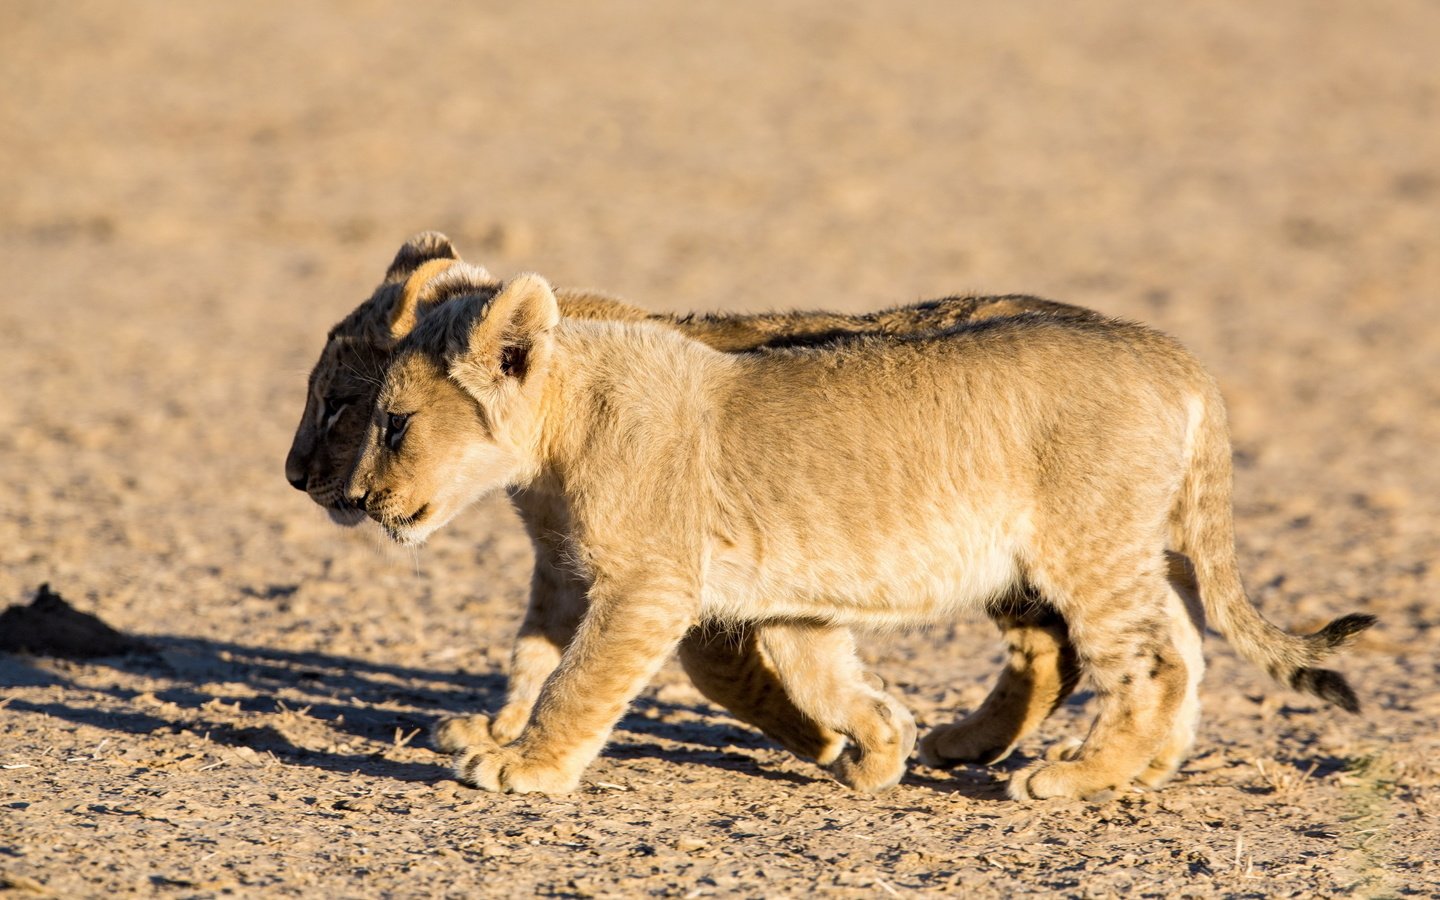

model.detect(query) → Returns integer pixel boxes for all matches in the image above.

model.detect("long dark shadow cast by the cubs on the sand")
[0,588,898,783]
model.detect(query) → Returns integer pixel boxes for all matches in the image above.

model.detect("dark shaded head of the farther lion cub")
[285,232,498,526]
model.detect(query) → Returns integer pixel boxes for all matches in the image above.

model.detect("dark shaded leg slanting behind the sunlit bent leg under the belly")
[680,622,845,766]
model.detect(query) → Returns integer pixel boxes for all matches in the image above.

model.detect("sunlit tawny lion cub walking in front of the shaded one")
[347,264,1372,799]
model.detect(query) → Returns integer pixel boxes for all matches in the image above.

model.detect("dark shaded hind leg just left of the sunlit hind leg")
[920,589,1080,769]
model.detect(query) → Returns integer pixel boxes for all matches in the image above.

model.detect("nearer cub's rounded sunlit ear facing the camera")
[449,275,560,399]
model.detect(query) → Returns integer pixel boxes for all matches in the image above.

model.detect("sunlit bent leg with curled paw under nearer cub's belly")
[759,622,916,792]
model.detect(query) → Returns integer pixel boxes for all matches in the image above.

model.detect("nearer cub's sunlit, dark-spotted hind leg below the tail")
[1009,557,1197,801]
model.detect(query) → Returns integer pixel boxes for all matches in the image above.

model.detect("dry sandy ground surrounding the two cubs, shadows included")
[0,0,1440,897]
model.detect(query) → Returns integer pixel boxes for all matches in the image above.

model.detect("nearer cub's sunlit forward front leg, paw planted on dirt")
[455,577,698,793]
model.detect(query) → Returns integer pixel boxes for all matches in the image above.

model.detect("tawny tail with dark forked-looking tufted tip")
[1174,379,1375,713]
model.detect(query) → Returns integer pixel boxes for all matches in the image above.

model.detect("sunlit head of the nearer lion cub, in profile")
[346,270,560,544]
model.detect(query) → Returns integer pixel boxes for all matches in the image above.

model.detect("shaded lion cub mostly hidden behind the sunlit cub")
[295,232,1157,786]
